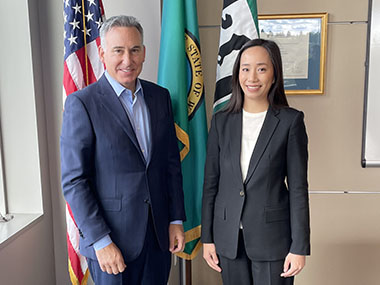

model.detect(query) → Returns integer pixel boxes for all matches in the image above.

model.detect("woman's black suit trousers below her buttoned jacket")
[218,231,294,285]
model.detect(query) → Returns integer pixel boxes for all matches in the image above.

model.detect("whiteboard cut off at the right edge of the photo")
[362,0,380,167]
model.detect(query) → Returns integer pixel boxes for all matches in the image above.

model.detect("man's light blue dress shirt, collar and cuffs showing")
[94,71,182,250]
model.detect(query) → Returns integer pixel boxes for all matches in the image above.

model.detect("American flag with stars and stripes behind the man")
[63,0,104,285]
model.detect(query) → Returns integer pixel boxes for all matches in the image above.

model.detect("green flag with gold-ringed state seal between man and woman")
[158,0,207,260]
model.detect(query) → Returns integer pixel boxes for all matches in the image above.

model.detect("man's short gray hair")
[99,15,144,50]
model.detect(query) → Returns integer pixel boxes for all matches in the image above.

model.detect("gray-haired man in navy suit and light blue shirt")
[61,16,185,285]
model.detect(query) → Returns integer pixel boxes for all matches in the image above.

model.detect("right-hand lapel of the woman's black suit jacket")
[244,107,279,184]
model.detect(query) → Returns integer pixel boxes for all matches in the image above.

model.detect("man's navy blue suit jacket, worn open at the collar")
[61,75,185,262]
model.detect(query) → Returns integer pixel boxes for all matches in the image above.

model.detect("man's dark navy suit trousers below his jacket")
[87,213,171,285]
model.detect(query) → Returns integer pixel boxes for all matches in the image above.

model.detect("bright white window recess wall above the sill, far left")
[0,1,42,213]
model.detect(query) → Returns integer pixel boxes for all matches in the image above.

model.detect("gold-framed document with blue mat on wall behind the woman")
[259,13,327,95]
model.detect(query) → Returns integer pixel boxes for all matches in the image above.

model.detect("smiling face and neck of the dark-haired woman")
[239,46,274,104]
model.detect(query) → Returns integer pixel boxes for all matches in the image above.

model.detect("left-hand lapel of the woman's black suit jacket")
[229,111,243,185]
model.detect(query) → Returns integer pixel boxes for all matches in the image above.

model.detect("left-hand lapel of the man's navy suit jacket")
[98,75,142,155]
